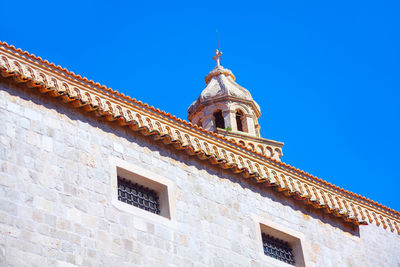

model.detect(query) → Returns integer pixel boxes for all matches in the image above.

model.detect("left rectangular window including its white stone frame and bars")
[110,157,177,228]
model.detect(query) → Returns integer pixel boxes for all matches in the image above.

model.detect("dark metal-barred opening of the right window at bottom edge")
[262,233,295,265]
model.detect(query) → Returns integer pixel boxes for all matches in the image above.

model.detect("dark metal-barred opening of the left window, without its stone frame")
[118,176,160,214]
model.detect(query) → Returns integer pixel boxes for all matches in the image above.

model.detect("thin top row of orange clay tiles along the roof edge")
[0,41,400,219]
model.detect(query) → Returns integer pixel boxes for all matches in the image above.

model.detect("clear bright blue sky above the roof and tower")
[0,0,400,210]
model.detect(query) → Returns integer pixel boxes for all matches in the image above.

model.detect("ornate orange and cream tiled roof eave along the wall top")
[0,43,400,234]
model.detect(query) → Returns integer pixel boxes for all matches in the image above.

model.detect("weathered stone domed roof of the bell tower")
[188,59,261,117]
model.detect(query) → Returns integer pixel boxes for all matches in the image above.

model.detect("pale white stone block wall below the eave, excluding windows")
[0,83,400,267]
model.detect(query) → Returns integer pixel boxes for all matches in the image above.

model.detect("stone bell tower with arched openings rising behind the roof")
[188,50,283,161]
